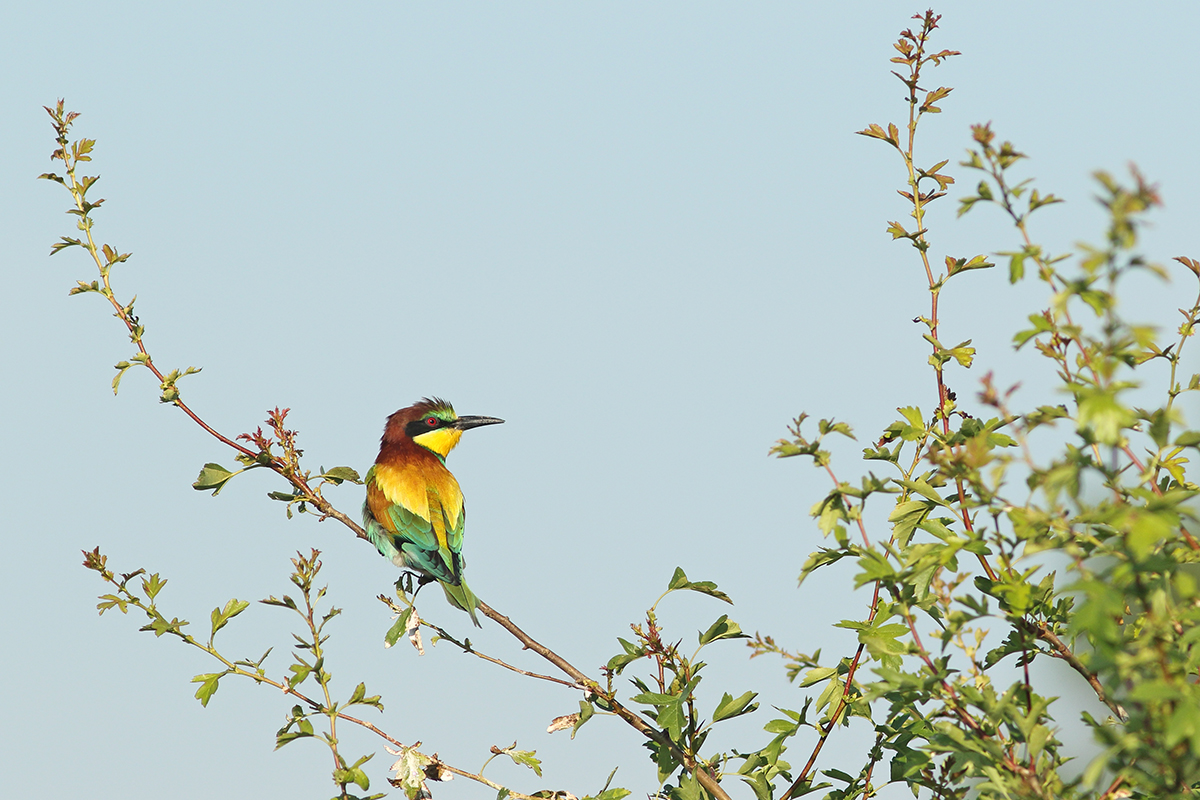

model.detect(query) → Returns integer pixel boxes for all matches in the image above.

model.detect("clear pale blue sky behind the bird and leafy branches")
[0,1,1200,799]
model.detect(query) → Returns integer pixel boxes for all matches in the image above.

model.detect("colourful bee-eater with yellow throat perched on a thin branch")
[362,397,504,627]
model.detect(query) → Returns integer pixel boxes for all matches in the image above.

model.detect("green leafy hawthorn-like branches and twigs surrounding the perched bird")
[49,12,1200,800]
